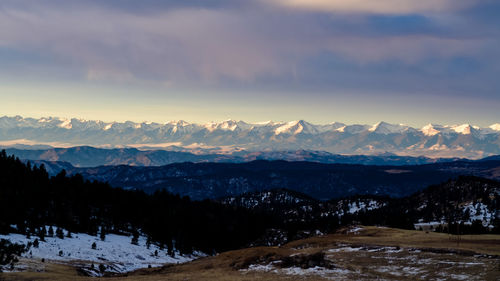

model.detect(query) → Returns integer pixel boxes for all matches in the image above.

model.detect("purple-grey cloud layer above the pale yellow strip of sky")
[0,0,500,124]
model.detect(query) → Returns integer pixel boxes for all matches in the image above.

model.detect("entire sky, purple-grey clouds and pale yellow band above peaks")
[0,0,500,126]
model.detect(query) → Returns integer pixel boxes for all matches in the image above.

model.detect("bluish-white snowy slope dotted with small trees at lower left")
[0,227,204,275]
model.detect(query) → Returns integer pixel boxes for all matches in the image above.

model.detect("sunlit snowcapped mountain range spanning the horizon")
[0,116,500,158]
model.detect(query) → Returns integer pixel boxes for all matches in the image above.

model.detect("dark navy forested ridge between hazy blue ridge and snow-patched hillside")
[53,160,500,200]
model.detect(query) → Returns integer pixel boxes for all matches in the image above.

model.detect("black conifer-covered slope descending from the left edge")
[0,151,277,254]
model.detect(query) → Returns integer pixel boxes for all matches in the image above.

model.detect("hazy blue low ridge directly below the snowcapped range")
[5,146,463,167]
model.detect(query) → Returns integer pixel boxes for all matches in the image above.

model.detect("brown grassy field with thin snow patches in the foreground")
[0,227,500,281]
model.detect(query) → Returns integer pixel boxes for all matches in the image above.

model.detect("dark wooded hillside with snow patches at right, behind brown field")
[220,176,500,234]
